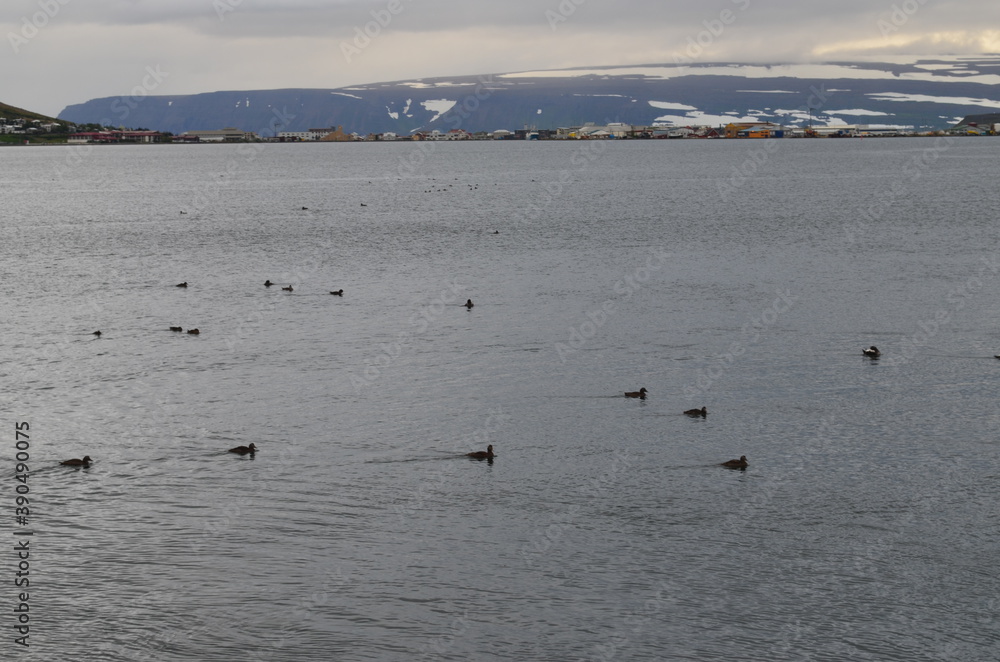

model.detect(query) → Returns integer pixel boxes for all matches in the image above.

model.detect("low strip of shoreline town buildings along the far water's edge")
[0,114,1000,145]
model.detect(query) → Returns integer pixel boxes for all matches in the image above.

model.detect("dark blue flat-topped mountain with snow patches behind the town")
[59,58,1000,136]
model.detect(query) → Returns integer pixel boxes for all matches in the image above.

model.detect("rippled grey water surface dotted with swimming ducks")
[0,139,1000,662]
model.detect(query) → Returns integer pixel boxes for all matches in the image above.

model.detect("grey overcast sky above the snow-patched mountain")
[0,0,1000,115]
